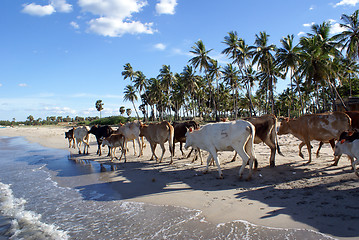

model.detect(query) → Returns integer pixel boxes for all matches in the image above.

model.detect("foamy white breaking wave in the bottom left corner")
[0,182,69,240]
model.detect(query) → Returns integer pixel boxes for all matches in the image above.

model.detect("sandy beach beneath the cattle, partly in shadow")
[0,126,359,239]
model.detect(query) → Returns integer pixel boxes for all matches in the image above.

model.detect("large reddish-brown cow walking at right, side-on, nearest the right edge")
[278,112,351,164]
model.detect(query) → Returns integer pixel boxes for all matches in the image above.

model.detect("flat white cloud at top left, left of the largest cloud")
[22,0,72,17]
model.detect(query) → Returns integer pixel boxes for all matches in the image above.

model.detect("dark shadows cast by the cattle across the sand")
[54,148,359,240]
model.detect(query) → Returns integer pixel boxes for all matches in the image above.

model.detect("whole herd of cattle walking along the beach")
[65,111,359,179]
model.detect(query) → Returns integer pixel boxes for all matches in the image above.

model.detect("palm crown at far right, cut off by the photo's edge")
[334,10,359,59]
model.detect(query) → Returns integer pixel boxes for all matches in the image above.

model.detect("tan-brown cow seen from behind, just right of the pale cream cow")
[140,121,174,164]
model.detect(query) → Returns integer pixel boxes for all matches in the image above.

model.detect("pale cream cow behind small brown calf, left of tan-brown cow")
[116,121,143,157]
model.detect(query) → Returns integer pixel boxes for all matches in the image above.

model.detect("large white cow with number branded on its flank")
[185,120,256,179]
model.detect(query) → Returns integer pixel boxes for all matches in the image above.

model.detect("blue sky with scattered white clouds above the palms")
[0,0,359,121]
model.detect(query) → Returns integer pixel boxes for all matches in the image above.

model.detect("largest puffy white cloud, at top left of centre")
[78,0,155,37]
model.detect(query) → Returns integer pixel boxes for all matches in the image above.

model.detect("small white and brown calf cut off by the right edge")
[334,132,359,177]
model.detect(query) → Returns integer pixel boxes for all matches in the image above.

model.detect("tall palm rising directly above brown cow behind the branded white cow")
[251,32,276,114]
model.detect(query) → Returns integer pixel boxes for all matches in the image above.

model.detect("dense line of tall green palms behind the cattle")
[122,10,359,121]
